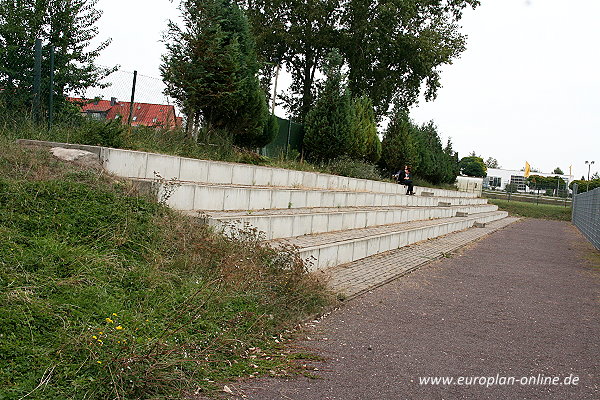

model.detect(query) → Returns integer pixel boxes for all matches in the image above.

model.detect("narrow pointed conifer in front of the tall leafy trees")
[303,52,353,161]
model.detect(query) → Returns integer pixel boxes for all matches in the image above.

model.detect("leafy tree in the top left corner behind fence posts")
[0,0,115,112]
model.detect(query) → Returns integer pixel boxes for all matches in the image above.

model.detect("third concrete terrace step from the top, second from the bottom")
[188,204,498,240]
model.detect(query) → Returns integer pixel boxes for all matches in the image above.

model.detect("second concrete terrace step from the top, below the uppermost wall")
[134,179,487,211]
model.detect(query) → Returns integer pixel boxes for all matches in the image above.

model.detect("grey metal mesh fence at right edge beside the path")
[571,184,600,250]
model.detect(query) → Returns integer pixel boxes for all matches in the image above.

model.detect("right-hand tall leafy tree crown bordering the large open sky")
[341,0,479,116]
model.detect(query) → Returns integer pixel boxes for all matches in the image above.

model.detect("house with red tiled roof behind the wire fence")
[68,97,181,129]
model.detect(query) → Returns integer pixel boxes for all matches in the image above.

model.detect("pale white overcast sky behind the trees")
[91,0,600,179]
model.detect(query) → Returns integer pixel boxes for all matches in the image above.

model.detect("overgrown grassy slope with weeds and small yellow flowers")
[0,137,331,399]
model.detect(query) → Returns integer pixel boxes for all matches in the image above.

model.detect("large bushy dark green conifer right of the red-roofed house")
[161,0,270,148]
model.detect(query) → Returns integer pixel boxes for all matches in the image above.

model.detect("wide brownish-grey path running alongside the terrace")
[226,220,600,400]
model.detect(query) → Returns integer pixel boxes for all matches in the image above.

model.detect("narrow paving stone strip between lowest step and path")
[319,218,518,298]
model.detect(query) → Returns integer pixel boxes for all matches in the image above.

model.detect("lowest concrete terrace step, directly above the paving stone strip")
[271,211,508,271]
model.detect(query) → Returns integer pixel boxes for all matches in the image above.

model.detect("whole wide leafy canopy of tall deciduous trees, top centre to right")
[244,0,479,122]
